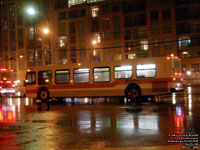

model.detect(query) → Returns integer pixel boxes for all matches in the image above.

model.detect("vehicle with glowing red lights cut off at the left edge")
[0,68,16,96]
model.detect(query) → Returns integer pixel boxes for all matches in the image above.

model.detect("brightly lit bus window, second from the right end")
[114,65,133,79]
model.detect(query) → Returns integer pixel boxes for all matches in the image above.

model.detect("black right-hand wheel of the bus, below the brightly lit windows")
[125,85,142,103]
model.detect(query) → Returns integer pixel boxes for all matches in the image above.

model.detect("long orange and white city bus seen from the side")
[25,56,183,101]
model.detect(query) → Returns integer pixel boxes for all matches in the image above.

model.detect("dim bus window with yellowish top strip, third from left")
[55,69,70,84]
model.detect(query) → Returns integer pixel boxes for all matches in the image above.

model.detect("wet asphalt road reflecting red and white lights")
[0,87,200,150]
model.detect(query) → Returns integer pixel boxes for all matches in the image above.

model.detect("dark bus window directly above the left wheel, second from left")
[38,70,52,85]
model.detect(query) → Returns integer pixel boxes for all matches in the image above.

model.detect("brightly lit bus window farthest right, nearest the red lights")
[136,64,156,78]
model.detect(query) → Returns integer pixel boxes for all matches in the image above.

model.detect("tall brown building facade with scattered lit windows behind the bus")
[0,0,200,87]
